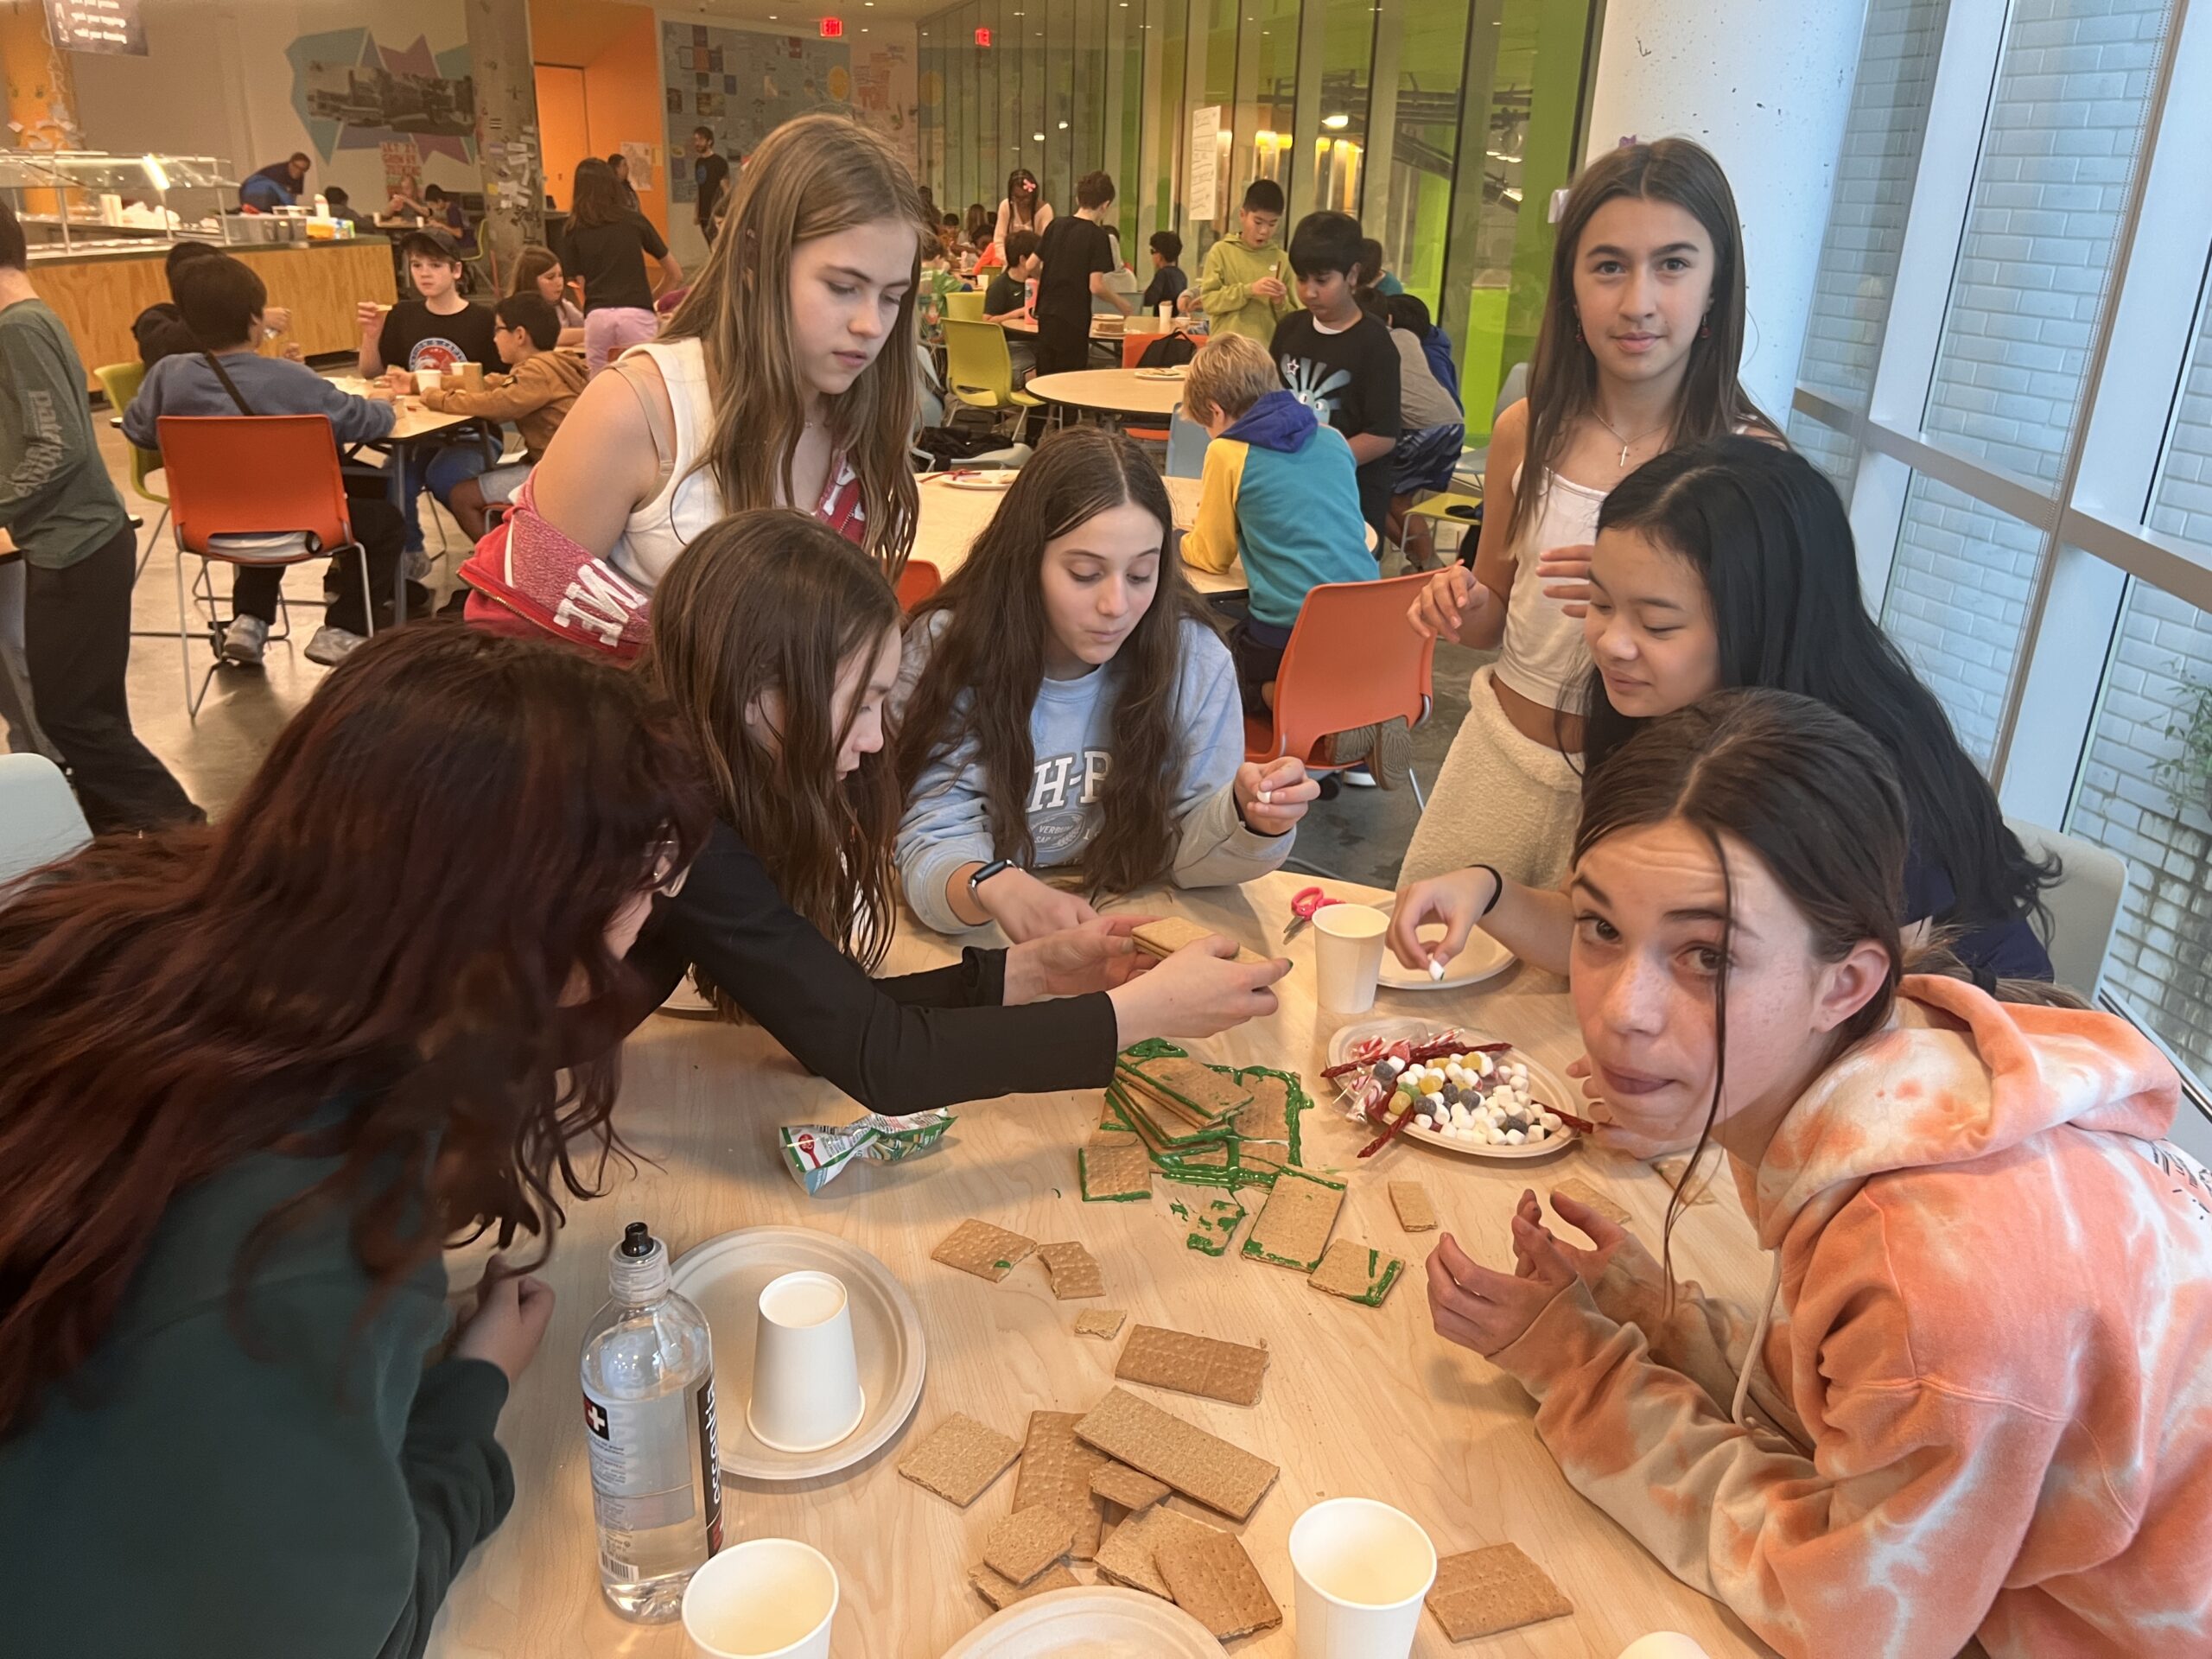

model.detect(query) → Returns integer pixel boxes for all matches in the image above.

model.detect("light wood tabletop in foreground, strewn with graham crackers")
[429,874,1767,1659]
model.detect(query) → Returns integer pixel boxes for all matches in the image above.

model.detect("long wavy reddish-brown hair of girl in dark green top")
[0,628,710,1433]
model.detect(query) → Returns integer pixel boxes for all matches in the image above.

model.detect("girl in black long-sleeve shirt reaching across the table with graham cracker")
[631,509,1287,1115]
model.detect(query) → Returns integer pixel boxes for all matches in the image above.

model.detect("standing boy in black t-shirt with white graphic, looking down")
[1269,213,1400,537]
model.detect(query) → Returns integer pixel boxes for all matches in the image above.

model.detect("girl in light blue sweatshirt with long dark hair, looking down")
[893,427,1320,943]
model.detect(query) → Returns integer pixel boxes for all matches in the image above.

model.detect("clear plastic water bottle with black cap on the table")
[584,1221,721,1624]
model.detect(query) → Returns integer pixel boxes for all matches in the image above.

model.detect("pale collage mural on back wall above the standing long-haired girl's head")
[661,20,912,201]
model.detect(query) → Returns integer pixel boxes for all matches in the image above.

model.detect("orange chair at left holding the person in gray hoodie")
[157,416,407,721]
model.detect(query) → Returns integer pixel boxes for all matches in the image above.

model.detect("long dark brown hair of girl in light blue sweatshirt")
[898,427,1204,893]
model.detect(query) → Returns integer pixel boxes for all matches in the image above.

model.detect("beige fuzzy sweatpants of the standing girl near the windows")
[1398,668,1581,887]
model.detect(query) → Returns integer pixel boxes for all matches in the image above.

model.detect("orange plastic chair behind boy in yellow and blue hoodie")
[1245,570,1435,801]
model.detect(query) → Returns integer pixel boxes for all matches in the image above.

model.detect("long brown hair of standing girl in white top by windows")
[1506,139,1781,546]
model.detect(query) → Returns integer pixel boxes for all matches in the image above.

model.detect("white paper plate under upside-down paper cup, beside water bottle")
[672,1228,929,1480]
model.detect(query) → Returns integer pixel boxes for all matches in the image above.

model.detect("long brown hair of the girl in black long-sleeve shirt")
[639,506,898,973]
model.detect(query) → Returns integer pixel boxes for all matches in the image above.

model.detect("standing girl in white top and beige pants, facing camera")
[1398,139,1774,887]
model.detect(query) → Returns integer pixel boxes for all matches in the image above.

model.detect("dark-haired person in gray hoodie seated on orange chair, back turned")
[124,254,427,666]
